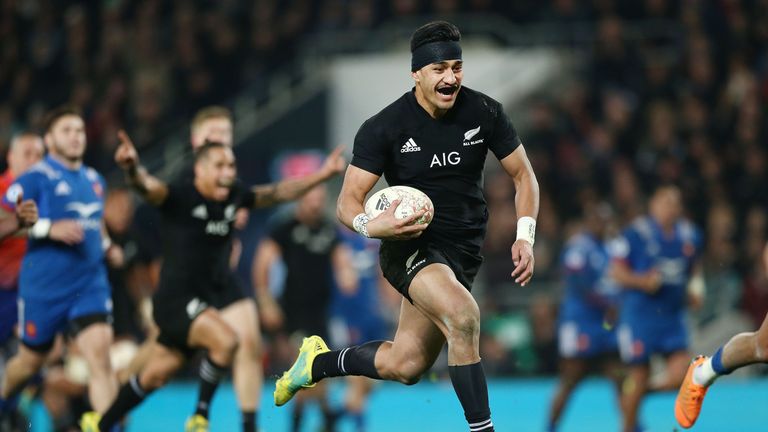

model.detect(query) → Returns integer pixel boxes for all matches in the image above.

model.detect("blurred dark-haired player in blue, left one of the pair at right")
[549,202,621,431]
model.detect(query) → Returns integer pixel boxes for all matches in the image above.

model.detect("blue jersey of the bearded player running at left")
[3,156,106,298]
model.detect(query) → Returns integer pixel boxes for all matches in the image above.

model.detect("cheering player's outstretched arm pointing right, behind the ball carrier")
[251,146,347,207]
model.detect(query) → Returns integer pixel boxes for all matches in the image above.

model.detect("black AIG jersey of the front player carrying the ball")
[351,87,520,253]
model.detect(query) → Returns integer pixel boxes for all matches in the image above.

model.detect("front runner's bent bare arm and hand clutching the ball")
[336,165,427,240]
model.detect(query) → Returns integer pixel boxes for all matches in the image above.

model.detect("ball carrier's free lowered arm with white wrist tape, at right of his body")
[501,145,539,286]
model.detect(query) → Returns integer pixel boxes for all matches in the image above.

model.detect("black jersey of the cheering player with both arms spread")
[159,181,255,289]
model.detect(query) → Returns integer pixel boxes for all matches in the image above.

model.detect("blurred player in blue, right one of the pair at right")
[612,185,702,432]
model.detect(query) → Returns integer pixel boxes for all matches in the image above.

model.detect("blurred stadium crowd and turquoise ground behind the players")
[0,0,768,431]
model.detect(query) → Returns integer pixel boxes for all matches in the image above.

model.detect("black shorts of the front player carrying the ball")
[379,238,483,303]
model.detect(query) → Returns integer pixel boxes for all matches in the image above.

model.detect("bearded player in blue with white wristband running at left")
[2,106,117,418]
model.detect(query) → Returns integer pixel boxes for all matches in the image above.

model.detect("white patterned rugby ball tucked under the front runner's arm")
[365,186,435,224]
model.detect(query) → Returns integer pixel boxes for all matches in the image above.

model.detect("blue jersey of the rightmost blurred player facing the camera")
[614,216,702,322]
